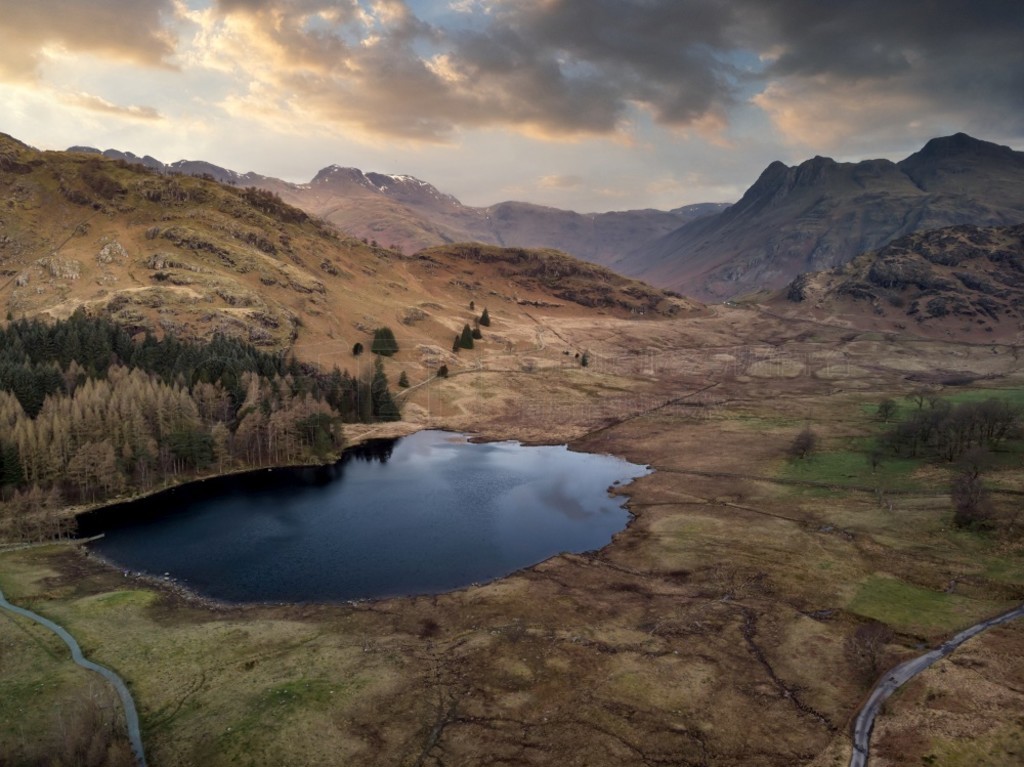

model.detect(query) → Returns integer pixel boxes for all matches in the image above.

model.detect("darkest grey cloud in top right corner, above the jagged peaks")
[751,0,1024,150]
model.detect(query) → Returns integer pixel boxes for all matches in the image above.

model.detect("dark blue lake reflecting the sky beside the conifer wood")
[79,431,648,602]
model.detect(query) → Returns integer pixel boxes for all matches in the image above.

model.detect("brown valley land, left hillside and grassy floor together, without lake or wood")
[0,141,1024,767]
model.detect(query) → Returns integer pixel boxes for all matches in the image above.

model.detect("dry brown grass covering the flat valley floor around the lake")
[0,307,1024,767]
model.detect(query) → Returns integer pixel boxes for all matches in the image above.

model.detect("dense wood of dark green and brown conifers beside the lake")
[0,311,400,539]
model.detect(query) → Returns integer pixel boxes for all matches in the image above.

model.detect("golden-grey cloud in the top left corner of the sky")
[0,0,174,82]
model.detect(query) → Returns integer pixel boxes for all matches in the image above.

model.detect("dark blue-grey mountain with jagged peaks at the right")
[612,133,1024,300]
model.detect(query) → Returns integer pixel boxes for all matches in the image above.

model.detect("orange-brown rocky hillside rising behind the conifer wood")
[0,136,694,365]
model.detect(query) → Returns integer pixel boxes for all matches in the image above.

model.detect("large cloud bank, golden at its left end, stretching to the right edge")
[186,0,1024,145]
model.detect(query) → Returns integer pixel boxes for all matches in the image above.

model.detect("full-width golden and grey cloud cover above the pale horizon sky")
[0,0,1024,177]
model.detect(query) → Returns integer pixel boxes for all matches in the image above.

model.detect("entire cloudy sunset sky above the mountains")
[0,0,1024,212]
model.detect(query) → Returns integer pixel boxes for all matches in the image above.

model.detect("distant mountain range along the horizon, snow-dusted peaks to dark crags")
[72,133,1024,301]
